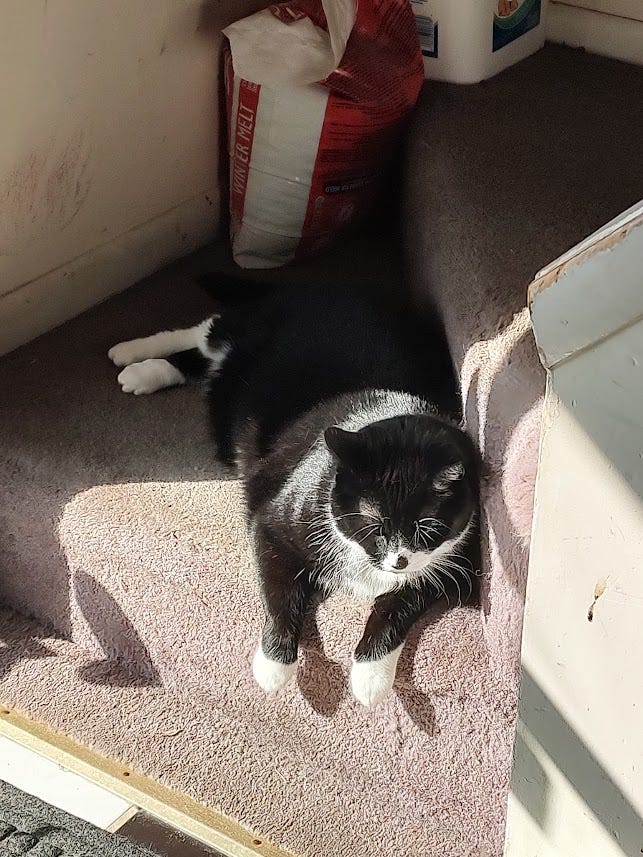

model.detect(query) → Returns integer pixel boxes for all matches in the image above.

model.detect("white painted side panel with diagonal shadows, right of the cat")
[505,205,643,857]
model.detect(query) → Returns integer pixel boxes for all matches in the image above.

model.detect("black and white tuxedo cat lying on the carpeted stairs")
[109,277,478,705]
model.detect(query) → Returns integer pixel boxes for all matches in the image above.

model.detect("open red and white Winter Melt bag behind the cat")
[224,0,424,268]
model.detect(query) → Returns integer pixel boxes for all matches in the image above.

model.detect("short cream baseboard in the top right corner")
[546,0,643,65]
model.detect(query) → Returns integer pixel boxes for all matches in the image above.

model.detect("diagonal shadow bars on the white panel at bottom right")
[512,670,643,855]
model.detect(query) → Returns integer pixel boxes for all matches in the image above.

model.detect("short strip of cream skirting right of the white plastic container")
[546,0,643,65]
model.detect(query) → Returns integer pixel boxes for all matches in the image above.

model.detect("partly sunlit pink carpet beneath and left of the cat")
[0,252,515,857]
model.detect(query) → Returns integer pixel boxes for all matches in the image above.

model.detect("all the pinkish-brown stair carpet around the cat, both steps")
[0,43,643,857]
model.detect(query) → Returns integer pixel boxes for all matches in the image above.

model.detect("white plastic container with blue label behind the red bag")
[411,0,547,83]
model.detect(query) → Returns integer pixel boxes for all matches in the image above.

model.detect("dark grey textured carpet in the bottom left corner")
[0,782,158,857]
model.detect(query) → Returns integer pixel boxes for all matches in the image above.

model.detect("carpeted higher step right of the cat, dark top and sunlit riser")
[403,45,643,687]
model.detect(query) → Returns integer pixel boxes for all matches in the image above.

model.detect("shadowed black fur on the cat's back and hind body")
[209,283,460,463]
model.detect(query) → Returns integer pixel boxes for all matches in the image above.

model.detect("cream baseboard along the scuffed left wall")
[0,189,220,354]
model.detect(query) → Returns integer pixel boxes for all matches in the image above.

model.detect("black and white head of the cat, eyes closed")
[325,414,479,575]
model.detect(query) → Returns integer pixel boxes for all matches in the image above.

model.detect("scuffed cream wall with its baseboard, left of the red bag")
[0,0,262,353]
